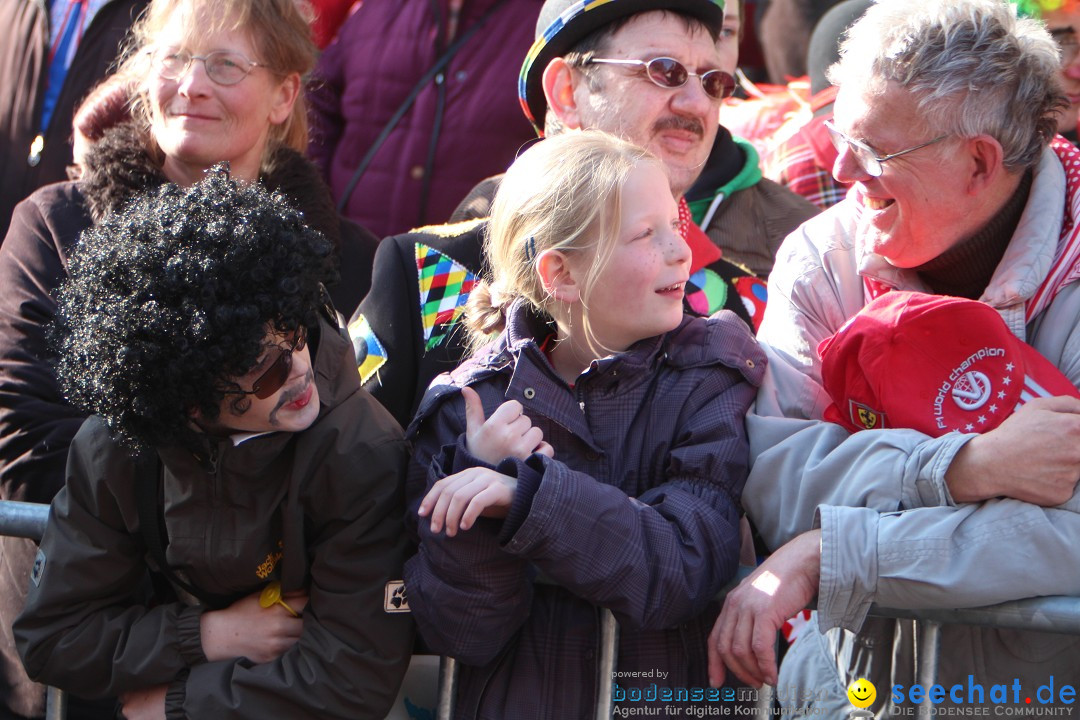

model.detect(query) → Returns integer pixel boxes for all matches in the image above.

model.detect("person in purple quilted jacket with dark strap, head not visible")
[310,0,542,236]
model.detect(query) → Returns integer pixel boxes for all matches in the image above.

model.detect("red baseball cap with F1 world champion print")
[818,291,1080,436]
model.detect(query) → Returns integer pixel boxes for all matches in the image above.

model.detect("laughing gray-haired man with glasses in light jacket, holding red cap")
[710,0,1080,717]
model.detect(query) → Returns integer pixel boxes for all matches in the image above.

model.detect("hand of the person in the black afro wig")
[199,592,308,663]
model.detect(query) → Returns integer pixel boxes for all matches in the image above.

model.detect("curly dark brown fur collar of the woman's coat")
[79,122,341,248]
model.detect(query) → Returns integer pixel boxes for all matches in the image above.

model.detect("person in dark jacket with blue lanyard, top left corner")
[0,0,147,237]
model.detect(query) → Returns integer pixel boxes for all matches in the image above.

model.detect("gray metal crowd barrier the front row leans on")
[6,500,1080,720]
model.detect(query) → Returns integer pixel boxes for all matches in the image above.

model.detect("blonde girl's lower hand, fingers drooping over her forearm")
[417,468,517,538]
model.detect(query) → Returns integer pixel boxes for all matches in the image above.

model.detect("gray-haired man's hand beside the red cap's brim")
[945,397,1080,507]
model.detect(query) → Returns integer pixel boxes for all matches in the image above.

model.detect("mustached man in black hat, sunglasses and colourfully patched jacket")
[350,0,818,423]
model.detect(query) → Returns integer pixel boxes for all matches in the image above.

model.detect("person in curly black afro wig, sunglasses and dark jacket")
[14,168,413,720]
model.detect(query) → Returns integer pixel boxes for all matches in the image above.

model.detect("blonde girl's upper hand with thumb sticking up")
[461,388,555,465]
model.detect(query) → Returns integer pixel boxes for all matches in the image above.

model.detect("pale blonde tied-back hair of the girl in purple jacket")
[464,130,663,350]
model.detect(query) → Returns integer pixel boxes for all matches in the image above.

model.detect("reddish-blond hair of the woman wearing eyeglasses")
[118,0,319,161]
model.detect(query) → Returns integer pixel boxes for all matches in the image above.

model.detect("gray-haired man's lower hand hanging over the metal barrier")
[708,530,821,688]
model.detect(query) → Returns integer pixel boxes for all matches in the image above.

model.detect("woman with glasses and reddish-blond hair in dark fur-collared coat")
[0,0,377,717]
